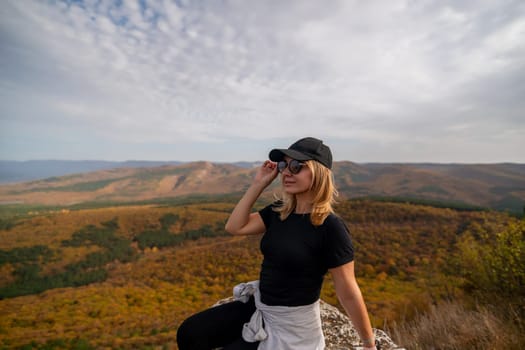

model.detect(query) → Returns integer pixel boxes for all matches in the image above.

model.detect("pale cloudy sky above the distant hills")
[0,0,525,163]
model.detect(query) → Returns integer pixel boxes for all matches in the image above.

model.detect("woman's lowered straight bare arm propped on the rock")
[330,261,375,349]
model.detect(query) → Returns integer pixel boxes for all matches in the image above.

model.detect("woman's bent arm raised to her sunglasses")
[225,160,277,235]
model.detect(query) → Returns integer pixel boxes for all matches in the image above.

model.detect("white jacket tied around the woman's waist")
[233,281,325,350]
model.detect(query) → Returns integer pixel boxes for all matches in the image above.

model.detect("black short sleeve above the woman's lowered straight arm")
[323,214,354,269]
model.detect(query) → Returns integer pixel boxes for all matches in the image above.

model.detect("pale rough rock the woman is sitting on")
[215,298,404,350]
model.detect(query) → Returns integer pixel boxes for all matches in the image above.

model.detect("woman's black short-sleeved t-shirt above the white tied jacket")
[259,205,354,306]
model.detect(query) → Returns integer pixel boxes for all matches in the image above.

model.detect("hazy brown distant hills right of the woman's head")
[334,162,525,213]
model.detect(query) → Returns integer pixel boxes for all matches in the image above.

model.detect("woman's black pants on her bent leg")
[177,297,259,350]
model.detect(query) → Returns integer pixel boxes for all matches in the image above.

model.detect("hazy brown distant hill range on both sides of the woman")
[0,161,525,213]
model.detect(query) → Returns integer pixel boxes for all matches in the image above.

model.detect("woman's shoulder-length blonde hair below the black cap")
[275,160,338,226]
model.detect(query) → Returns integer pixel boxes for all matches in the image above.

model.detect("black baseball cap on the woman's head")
[269,137,332,169]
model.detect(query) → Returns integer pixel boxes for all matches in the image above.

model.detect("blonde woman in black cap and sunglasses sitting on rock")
[177,137,376,350]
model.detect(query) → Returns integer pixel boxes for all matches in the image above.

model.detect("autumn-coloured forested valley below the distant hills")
[0,200,525,349]
